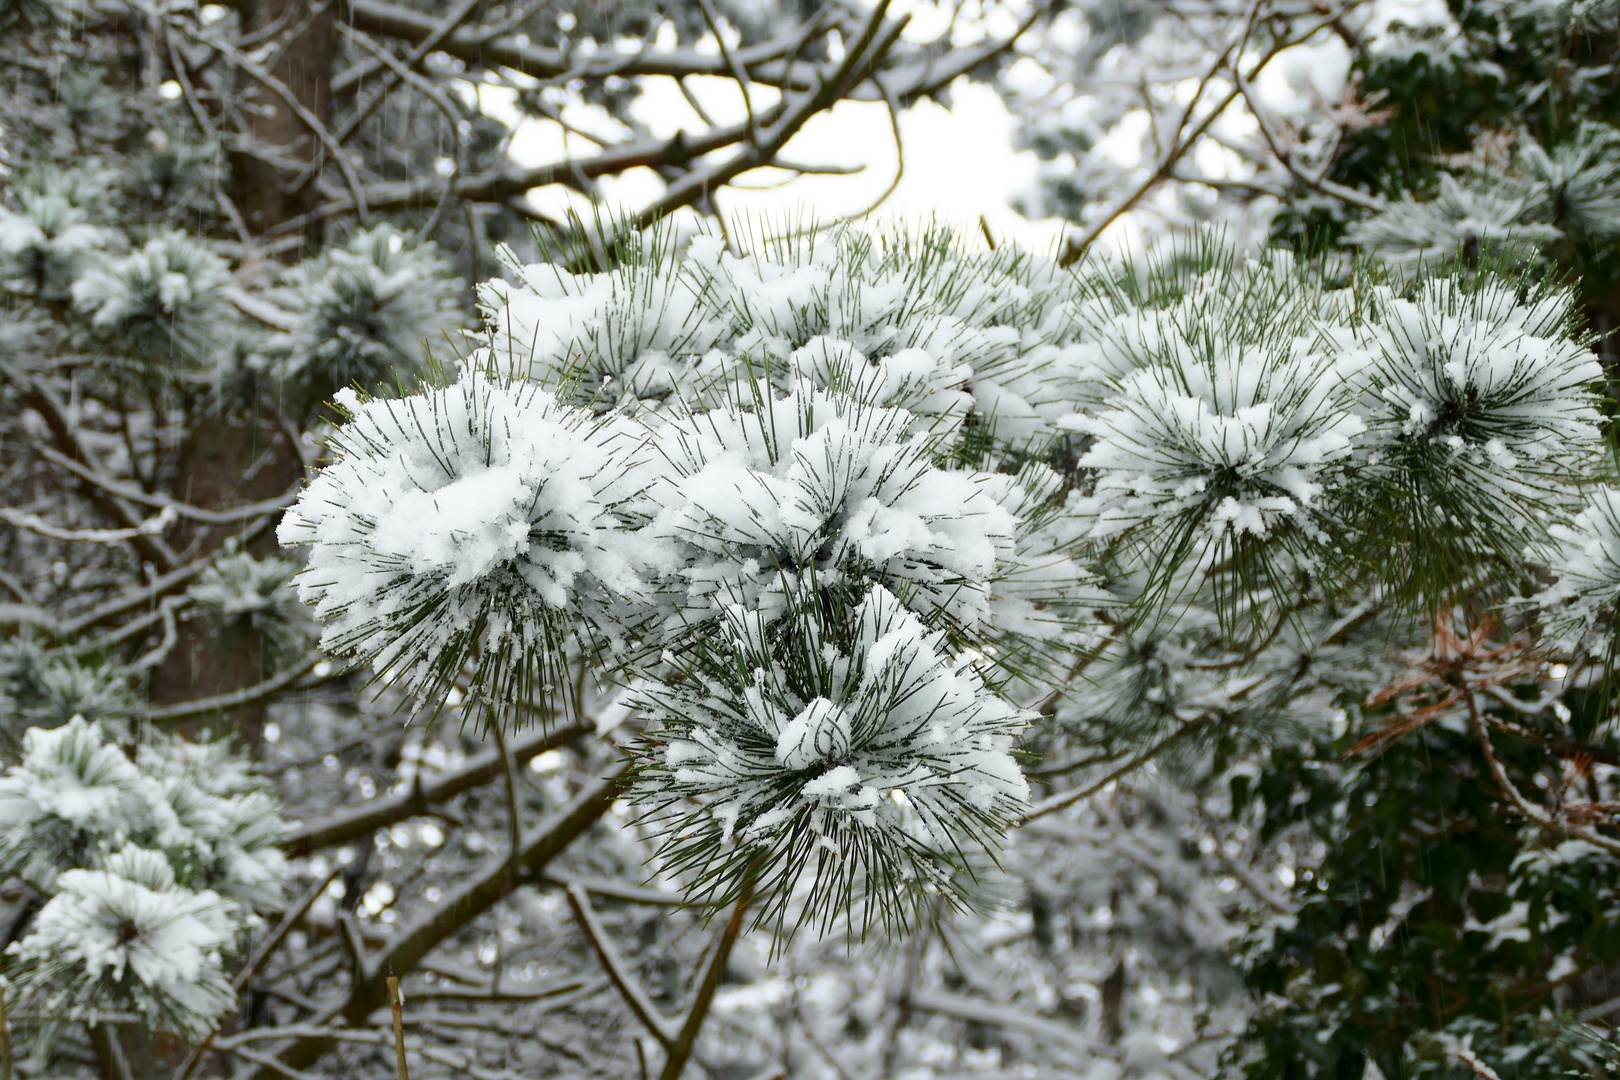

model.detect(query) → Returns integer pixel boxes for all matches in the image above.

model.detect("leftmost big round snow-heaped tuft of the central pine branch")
[279,371,646,718]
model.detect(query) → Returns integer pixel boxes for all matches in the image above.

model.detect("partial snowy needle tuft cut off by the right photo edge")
[1536,487,1620,657]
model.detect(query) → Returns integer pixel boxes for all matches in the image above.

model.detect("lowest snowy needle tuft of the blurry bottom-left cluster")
[5,847,240,1040]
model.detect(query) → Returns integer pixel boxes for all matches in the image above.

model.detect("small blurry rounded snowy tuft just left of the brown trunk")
[73,232,230,377]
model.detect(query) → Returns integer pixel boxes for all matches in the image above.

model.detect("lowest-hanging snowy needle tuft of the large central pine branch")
[635,586,1029,931]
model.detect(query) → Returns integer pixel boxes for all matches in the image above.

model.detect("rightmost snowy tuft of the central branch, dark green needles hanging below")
[1358,279,1602,592]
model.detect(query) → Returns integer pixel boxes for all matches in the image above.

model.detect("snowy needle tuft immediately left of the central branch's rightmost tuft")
[1063,250,1366,592]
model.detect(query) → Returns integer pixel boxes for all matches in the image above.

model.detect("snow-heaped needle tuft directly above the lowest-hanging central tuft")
[651,384,1016,627]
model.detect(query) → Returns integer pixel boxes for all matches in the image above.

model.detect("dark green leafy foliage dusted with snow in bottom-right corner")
[1231,696,1620,1080]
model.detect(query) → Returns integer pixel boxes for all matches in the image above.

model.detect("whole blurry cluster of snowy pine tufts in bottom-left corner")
[0,717,290,1041]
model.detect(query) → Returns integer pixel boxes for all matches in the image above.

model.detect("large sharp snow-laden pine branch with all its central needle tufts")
[282,223,1599,931]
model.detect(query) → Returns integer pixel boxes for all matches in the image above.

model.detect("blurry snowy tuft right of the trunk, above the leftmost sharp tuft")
[262,225,458,405]
